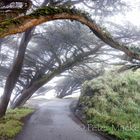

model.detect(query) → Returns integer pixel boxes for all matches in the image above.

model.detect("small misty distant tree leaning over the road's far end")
[55,64,104,98]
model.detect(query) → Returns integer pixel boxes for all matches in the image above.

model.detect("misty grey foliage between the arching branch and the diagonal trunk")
[10,22,103,107]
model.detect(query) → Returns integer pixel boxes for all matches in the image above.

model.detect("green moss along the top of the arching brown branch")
[0,6,91,33]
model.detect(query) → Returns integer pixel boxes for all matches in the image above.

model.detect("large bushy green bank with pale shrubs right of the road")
[78,71,140,140]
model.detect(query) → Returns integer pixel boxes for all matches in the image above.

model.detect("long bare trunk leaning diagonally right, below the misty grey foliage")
[11,47,100,109]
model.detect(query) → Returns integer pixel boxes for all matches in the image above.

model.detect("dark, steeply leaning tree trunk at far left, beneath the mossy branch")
[0,28,32,117]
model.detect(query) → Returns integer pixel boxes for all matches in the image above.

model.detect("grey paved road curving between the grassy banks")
[16,99,106,140]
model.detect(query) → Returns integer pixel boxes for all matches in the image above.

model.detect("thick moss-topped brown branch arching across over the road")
[0,0,140,117]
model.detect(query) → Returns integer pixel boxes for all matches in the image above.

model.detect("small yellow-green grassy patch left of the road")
[0,108,33,140]
